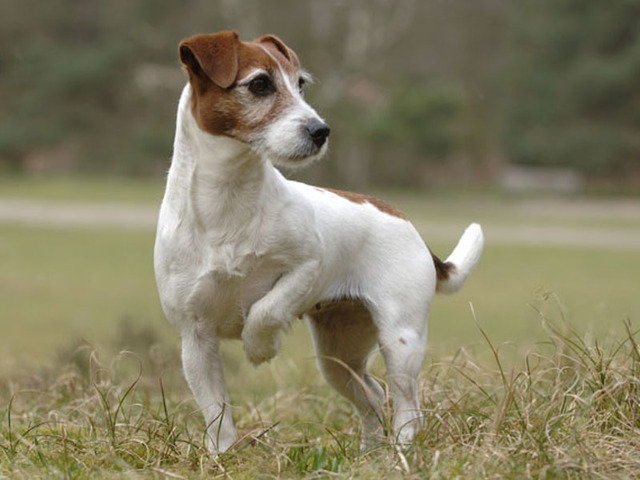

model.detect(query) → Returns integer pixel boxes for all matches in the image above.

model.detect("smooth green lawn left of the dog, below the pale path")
[0,226,169,368]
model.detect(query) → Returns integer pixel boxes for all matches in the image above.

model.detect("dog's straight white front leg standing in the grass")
[182,321,237,454]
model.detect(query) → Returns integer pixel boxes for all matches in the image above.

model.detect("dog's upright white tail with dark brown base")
[431,223,484,294]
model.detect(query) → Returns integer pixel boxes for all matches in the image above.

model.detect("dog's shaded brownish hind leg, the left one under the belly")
[308,300,385,445]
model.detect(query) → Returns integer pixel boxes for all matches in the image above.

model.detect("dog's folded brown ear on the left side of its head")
[180,32,239,88]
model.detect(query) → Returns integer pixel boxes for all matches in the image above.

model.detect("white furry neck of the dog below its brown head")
[168,85,274,229]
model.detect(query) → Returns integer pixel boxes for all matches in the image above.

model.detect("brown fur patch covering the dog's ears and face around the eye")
[180,32,300,142]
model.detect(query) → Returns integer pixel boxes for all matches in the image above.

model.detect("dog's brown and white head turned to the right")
[180,32,329,166]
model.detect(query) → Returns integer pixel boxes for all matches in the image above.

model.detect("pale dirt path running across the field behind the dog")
[0,199,640,249]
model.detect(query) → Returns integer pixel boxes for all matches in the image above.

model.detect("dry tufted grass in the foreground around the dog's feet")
[0,300,640,479]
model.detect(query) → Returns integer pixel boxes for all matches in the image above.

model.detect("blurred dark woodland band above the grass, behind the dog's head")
[0,0,640,187]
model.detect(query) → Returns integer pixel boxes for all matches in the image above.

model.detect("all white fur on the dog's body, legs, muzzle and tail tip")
[155,82,482,452]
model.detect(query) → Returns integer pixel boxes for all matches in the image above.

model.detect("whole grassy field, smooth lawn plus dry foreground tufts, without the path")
[0,179,640,478]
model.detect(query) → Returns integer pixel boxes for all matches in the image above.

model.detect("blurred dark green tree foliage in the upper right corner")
[503,0,640,176]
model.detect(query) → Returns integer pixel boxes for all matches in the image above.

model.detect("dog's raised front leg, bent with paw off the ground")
[242,259,320,365]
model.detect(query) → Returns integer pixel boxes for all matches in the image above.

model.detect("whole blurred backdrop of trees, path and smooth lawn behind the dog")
[0,0,640,376]
